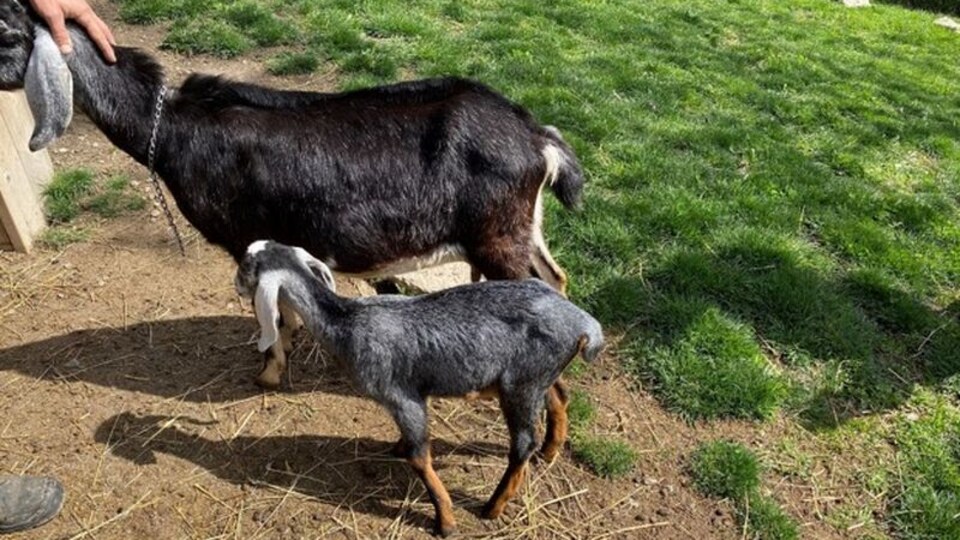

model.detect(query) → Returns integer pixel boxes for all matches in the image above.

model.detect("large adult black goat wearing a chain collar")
[0,7,583,386]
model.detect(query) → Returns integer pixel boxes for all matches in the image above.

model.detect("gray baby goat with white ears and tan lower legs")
[235,241,603,536]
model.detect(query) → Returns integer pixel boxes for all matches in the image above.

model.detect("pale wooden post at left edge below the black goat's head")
[0,92,53,252]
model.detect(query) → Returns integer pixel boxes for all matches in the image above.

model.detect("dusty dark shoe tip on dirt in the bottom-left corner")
[0,476,63,534]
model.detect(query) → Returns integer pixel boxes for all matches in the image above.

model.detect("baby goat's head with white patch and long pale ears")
[233,240,336,352]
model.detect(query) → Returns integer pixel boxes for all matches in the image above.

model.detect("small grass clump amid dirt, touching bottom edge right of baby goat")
[690,441,798,540]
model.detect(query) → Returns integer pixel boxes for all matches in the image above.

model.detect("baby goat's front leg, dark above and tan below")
[387,397,457,537]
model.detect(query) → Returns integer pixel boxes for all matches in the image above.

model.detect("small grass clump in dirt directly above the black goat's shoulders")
[160,18,253,58]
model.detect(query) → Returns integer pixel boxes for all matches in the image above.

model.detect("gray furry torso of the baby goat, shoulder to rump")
[340,279,603,395]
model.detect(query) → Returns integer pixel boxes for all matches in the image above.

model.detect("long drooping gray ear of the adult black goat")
[23,25,73,152]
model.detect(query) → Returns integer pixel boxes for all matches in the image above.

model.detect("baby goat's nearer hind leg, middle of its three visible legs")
[480,390,545,519]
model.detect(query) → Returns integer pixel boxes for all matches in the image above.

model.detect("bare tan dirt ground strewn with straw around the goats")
[0,1,860,540]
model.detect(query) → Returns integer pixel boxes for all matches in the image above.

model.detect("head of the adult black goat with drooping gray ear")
[0,0,73,151]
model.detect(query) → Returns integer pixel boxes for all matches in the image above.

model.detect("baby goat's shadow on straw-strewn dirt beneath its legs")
[94,412,498,528]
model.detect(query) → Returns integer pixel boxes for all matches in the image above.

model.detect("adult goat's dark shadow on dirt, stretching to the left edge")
[0,316,357,402]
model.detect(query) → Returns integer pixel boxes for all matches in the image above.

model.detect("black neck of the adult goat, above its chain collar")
[66,26,163,164]
